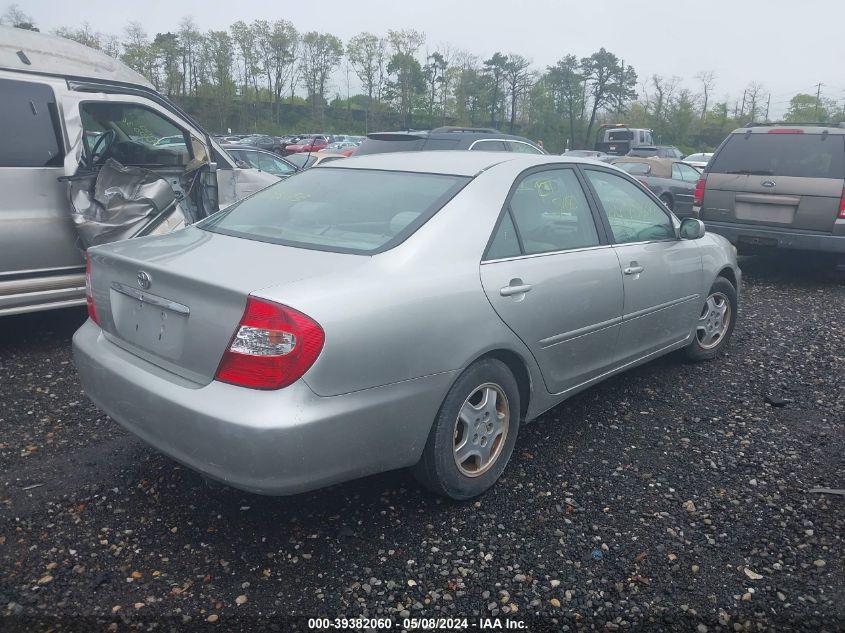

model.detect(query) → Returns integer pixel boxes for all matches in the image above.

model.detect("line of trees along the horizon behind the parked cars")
[0,5,845,152]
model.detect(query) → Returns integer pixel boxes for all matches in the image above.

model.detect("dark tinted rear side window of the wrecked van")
[0,79,64,167]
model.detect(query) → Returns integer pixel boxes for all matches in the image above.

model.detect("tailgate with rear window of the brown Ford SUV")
[701,128,845,232]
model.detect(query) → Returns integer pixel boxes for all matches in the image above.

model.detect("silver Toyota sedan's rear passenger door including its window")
[481,168,622,393]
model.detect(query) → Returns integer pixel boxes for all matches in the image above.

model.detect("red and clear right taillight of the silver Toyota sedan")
[215,297,325,389]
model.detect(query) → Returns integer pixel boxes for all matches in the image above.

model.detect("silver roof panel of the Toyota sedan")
[324,150,607,176]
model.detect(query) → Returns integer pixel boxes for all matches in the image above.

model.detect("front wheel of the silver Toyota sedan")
[684,277,738,361]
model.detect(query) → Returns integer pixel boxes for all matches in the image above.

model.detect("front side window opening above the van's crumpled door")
[80,101,191,166]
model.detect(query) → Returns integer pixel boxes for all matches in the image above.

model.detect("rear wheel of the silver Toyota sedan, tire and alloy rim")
[413,358,520,501]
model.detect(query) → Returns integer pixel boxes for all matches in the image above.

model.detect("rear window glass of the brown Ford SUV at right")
[707,134,845,179]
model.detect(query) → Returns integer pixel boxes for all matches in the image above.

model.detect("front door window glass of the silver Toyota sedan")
[586,169,676,244]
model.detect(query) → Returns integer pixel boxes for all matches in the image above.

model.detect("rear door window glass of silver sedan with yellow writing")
[510,169,599,255]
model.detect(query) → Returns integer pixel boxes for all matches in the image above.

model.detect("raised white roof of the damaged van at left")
[0,26,153,88]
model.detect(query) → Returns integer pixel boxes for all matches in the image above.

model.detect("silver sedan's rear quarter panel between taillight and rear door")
[252,163,542,396]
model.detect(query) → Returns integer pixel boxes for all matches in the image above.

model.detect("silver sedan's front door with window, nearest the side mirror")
[585,167,704,364]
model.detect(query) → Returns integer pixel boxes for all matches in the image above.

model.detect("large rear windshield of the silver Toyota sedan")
[198,167,471,254]
